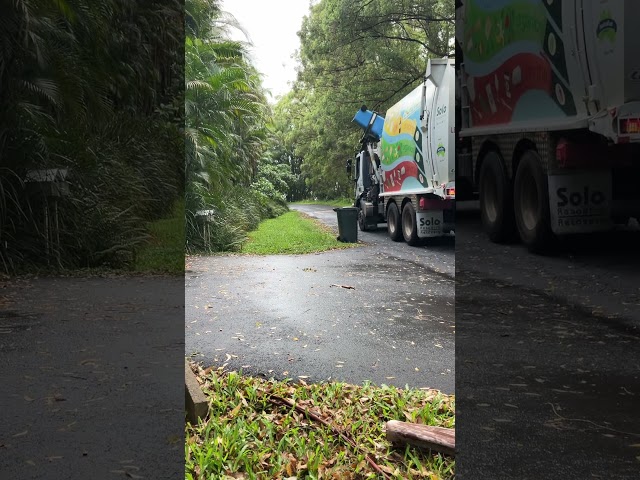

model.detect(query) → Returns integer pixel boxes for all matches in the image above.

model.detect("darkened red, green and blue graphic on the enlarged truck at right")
[461,0,577,127]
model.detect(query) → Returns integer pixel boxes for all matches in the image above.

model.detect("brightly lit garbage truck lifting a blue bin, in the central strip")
[347,58,455,245]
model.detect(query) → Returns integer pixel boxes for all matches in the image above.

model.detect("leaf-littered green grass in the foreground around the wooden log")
[185,366,455,480]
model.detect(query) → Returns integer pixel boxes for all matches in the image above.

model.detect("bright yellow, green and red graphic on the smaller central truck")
[380,86,427,192]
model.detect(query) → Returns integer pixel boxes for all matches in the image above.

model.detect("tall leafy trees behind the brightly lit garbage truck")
[276,0,455,198]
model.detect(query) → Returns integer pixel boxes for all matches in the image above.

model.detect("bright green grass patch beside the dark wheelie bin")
[241,211,357,255]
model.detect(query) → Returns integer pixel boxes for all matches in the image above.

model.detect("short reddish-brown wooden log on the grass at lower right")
[386,420,456,455]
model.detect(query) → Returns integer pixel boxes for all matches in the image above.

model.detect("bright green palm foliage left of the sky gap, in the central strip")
[185,0,294,251]
